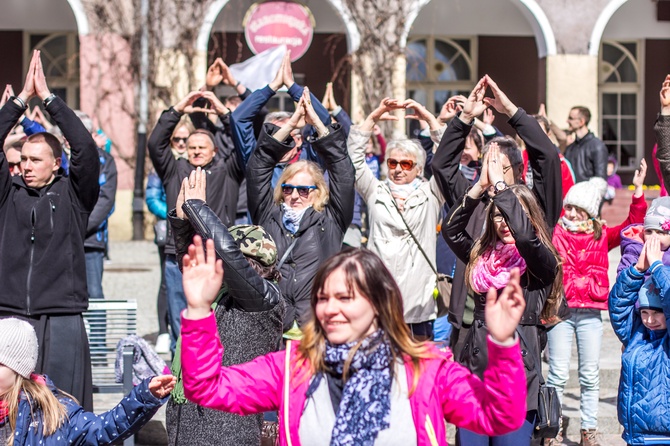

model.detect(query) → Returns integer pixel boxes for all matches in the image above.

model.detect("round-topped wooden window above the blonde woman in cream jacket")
[405,37,477,121]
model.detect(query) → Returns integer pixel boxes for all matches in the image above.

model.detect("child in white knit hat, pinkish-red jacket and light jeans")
[545,160,647,446]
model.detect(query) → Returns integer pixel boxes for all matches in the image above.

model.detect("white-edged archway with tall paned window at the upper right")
[589,0,670,184]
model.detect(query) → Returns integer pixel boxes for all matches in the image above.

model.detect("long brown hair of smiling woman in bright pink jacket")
[297,248,434,395]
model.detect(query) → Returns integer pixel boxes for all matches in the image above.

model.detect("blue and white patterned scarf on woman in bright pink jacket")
[307,329,391,446]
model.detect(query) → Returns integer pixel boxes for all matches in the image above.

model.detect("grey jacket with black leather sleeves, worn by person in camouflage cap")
[166,200,284,446]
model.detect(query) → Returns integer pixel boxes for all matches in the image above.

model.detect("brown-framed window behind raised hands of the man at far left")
[23,32,79,108]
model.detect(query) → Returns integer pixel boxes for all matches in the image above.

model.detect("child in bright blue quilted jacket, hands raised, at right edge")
[609,234,670,445]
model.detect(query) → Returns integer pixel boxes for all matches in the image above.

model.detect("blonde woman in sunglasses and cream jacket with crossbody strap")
[347,98,444,339]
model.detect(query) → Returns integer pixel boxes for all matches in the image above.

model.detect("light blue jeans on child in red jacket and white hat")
[547,308,603,429]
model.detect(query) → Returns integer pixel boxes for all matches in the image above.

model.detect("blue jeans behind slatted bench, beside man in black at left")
[84,250,107,358]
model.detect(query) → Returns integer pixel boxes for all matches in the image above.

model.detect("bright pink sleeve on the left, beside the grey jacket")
[181,313,284,415]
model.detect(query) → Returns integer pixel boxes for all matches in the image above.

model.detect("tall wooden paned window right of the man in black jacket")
[599,41,644,171]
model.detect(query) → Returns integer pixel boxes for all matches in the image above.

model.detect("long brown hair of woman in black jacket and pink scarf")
[465,184,563,319]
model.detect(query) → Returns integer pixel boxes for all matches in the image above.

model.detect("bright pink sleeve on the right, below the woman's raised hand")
[437,339,527,436]
